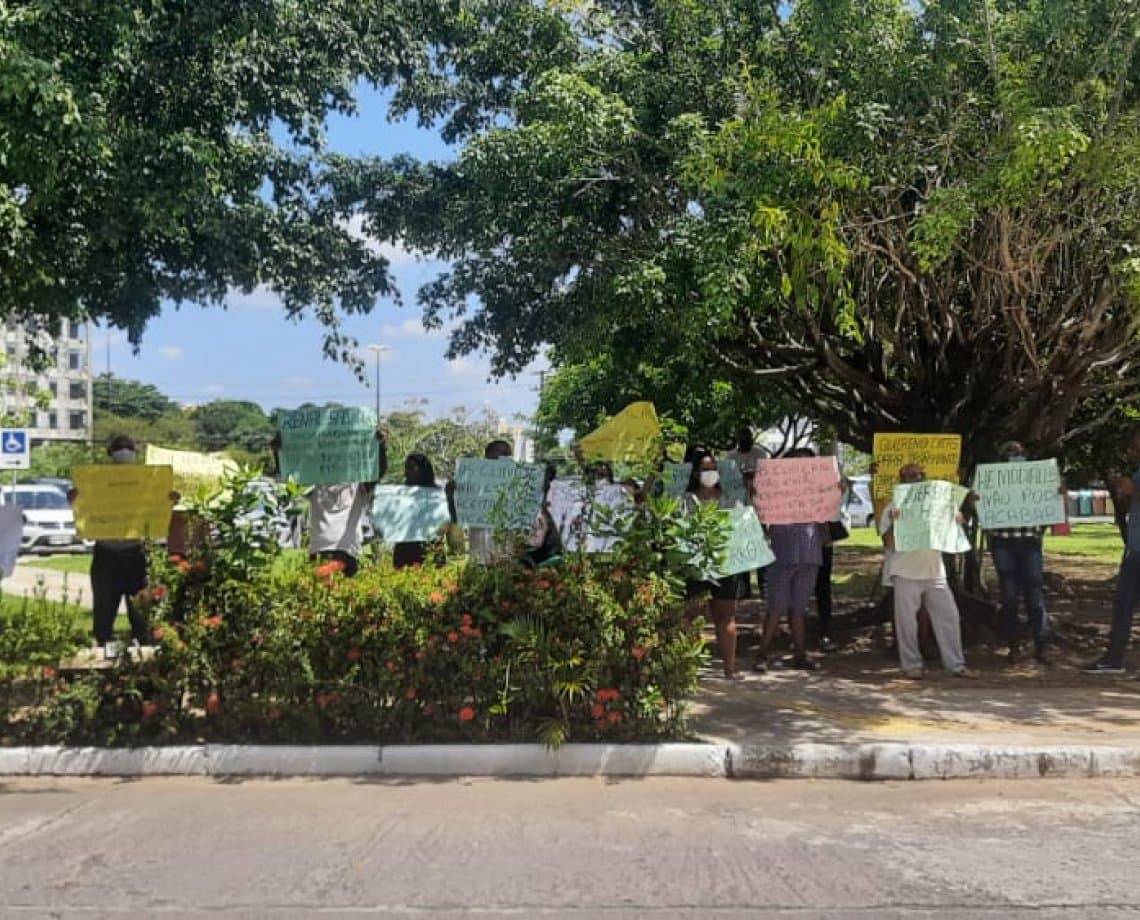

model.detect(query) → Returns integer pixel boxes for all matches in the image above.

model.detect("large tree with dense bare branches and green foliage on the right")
[362,0,1140,461]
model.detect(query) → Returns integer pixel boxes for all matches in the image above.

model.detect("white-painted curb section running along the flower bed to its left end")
[0,743,728,776]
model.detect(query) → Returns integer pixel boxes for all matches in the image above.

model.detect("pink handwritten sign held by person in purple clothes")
[754,457,842,524]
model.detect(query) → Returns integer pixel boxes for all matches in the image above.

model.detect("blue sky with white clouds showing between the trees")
[100,90,538,418]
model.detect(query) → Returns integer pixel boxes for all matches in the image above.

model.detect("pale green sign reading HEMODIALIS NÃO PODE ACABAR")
[974,459,1065,530]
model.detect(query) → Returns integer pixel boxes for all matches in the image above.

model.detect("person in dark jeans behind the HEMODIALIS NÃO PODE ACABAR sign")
[971,441,1049,665]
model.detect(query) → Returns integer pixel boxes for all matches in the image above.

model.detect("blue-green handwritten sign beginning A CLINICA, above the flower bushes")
[455,457,544,530]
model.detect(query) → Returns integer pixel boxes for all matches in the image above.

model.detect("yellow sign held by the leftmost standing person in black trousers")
[72,463,174,540]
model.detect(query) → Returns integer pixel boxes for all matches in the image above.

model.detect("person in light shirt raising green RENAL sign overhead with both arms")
[271,428,388,578]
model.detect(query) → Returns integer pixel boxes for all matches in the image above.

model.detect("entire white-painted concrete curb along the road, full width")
[0,742,1140,781]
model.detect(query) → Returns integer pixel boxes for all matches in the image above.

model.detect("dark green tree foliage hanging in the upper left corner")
[0,0,432,358]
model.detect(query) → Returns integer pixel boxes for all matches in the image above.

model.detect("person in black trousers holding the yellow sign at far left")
[67,434,168,646]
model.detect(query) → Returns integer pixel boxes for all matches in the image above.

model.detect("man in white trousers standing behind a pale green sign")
[879,463,972,681]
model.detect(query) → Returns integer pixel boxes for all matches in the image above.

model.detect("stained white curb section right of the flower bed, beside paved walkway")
[728,742,1140,780]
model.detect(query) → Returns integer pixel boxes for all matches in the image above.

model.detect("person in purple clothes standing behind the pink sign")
[752,447,828,671]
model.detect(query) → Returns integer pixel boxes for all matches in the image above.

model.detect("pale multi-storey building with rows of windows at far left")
[0,320,91,443]
